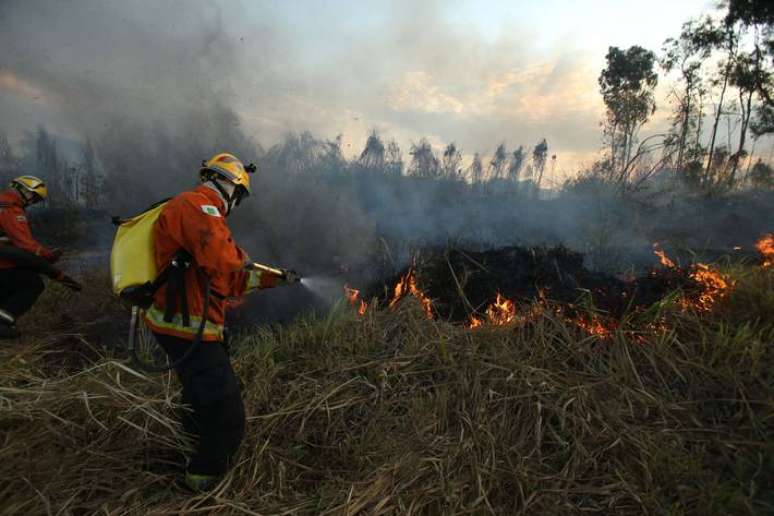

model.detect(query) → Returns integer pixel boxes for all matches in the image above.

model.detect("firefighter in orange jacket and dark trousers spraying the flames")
[145,154,298,491]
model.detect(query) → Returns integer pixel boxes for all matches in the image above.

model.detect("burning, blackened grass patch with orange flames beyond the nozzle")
[344,243,740,338]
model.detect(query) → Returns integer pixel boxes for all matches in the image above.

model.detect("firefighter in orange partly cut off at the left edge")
[0,176,62,339]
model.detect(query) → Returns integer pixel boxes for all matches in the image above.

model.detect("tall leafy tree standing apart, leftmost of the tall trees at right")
[599,45,658,167]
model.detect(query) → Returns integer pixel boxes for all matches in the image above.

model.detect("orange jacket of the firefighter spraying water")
[145,185,282,342]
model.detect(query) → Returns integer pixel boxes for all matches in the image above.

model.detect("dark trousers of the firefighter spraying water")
[154,333,245,475]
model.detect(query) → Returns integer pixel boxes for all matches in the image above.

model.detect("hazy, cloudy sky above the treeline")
[0,0,744,181]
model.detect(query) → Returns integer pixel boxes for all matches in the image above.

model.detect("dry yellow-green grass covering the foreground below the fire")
[0,269,774,515]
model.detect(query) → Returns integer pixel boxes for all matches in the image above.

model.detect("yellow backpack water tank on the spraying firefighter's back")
[110,201,166,295]
